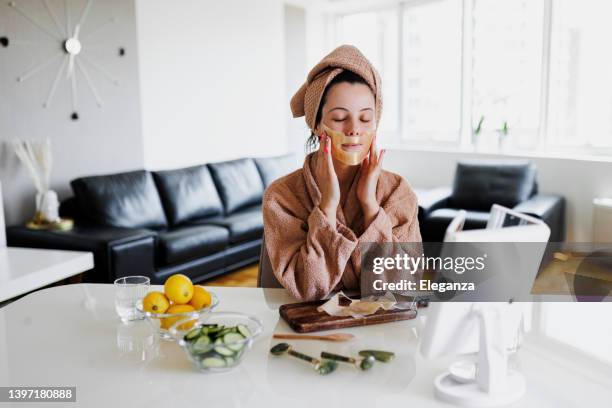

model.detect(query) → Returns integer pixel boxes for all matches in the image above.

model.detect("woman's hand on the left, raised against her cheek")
[315,133,340,228]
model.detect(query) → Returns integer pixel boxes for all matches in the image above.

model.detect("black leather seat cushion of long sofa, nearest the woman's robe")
[192,205,263,244]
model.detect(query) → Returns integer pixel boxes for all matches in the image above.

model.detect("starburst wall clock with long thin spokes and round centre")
[0,0,125,120]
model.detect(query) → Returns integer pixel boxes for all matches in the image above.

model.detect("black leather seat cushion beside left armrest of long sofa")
[158,225,229,265]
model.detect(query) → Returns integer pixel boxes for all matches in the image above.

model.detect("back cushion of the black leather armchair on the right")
[451,160,536,211]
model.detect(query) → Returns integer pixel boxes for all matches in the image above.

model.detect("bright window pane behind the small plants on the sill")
[471,0,543,147]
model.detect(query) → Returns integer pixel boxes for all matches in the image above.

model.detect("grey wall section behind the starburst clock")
[0,0,144,225]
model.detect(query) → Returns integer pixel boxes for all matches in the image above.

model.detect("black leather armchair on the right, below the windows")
[417,160,565,242]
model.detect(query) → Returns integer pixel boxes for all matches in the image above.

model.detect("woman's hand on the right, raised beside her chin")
[357,135,385,229]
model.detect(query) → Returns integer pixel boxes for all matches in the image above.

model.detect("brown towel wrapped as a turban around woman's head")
[291,45,382,130]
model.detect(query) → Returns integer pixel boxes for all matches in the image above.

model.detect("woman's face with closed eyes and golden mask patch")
[317,82,376,165]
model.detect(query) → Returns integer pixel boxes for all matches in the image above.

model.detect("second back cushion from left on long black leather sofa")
[153,165,223,225]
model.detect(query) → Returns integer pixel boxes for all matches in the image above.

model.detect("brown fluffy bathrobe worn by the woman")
[263,152,421,300]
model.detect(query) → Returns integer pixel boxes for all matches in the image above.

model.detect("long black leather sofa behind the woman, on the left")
[7,155,296,283]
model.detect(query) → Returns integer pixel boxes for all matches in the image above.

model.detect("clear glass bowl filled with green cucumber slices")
[170,312,263,372]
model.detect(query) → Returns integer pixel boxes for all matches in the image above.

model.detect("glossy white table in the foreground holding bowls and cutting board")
[0,284,612,408]
